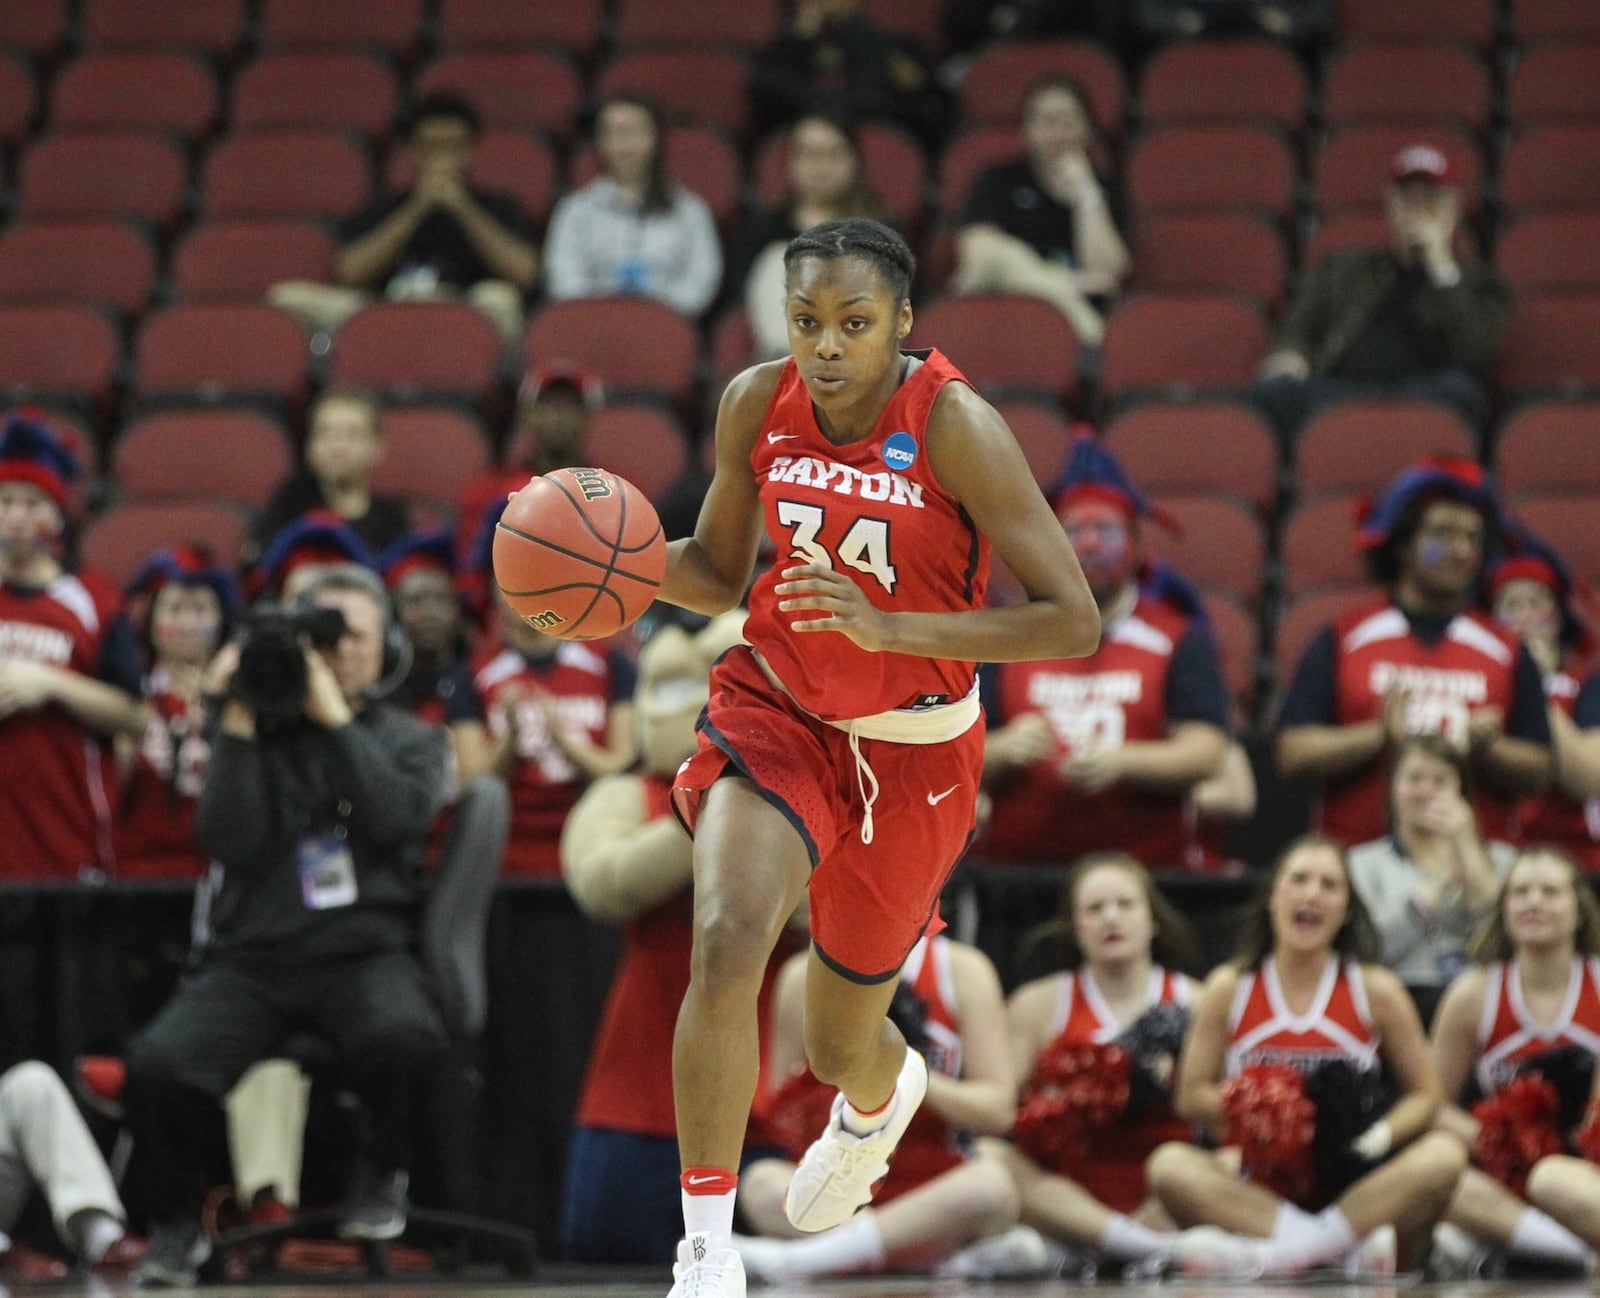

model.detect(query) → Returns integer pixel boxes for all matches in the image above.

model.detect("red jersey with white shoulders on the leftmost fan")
[0,576,115,880]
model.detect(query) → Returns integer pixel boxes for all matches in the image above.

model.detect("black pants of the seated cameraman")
[126,951,450,1224]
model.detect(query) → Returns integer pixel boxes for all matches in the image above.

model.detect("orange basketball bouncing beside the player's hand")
[493,469,667,640]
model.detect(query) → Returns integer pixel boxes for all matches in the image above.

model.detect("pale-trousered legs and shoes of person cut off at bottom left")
[0,1060,144,1284]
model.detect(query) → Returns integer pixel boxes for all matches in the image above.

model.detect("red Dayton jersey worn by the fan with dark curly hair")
[1322,599,1518,843]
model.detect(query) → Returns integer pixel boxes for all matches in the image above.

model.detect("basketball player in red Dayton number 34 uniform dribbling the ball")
[661,219,1099,1298]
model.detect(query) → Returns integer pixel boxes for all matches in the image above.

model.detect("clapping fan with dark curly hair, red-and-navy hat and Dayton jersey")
[1277,456,1550,843]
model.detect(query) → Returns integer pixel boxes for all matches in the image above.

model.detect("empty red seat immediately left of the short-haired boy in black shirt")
[112,410,294,508]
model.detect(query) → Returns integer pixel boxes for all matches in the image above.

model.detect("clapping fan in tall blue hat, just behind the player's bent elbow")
[974,435,1229,867]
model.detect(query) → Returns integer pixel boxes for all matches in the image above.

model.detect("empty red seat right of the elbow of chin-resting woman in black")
[1128,213,1288,309]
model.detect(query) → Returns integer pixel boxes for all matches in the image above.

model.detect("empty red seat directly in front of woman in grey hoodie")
[523,298,699,411]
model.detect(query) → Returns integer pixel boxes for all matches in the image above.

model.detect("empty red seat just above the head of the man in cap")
[1322,45,1490,133]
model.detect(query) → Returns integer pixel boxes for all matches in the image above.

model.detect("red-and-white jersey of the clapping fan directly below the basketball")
[474,642,611,879]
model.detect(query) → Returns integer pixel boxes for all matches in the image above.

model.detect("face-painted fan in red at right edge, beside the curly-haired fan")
[1490,533,1600,871]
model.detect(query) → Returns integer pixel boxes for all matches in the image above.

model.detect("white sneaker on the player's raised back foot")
[784,1048,928,1231]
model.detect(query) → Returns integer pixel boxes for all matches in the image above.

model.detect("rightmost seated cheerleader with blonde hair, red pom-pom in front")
[1434,848,1600,1269]
